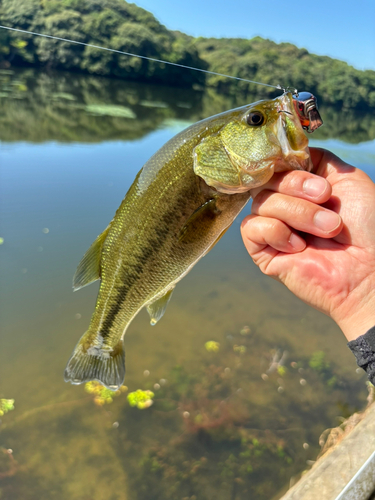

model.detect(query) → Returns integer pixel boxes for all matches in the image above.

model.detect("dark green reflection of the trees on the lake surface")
[0,69,375,143]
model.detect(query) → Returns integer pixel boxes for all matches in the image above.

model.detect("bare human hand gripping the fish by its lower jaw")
[241,148,375,340]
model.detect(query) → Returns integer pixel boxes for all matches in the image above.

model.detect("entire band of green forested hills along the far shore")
[0,0,375,111]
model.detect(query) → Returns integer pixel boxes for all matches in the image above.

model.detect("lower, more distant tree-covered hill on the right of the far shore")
[195,37,375,109]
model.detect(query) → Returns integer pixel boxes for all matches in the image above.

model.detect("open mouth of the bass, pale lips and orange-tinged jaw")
[274,93,313,172]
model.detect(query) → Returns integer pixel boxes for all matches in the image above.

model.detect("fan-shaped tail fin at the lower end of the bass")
[64,331,125,391]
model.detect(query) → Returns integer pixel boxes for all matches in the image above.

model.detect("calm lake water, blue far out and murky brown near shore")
[0,70,375,500]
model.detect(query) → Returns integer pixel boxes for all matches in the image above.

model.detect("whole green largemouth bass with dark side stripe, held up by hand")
[64,92,316,391]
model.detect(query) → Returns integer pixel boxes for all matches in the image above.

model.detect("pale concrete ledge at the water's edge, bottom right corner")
[280,404,375,500]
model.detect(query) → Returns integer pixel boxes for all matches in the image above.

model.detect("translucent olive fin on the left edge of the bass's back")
[73,225,111,291]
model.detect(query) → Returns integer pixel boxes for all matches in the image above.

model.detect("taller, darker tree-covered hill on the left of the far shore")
[0,0,207,86]
